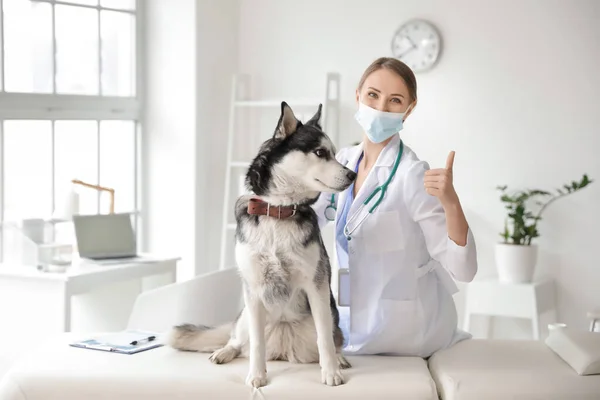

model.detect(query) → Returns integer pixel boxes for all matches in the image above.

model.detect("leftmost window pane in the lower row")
[4,121,52,220]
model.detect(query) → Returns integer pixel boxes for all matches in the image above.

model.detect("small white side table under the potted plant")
[463,279,556,340]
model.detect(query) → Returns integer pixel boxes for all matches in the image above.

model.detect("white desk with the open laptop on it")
[0,258,179,332]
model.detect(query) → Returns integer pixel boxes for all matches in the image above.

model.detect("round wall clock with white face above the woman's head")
[392,20,442,72]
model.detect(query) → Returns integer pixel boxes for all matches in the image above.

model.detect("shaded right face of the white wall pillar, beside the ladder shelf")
[196,0,240,273]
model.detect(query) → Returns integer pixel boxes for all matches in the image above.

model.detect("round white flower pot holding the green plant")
[496,243,538,283]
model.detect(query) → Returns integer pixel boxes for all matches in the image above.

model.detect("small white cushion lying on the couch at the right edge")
[545,328,600,375]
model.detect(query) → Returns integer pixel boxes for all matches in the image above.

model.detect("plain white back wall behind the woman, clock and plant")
[239,0,600,337]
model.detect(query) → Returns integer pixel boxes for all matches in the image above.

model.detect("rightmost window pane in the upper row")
[100,11,135,96]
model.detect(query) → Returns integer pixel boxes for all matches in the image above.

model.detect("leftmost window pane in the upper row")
[3,0,53,93]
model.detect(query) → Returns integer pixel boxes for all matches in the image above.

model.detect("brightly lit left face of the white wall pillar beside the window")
[142,0,197,277]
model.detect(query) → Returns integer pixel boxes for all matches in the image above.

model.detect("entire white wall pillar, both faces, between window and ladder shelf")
[142,0,239,279]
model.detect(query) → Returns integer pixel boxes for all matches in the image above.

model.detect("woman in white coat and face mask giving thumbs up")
[313,58,477,358]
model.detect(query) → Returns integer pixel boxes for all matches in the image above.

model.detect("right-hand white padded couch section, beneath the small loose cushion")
[429,339,600,400]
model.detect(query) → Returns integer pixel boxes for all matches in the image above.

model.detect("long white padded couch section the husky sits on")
[0,335,437,400]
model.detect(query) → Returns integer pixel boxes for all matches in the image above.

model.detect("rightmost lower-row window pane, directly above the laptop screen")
[100,121,135,213]
